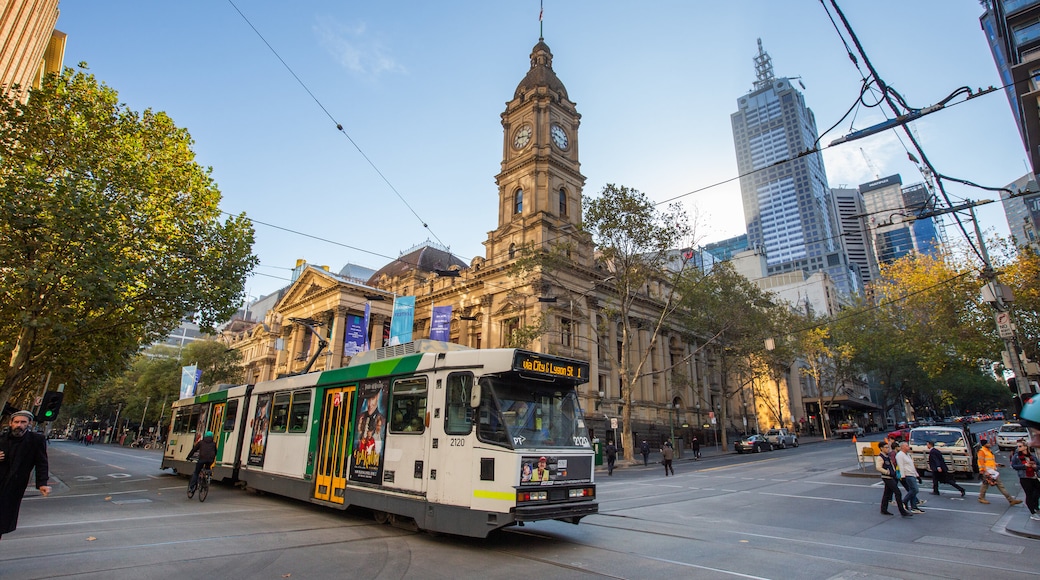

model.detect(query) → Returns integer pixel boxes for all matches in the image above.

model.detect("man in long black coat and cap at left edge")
[0,411,51,534]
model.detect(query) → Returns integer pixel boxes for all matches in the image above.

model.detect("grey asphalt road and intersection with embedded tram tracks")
[0,422,1040,580]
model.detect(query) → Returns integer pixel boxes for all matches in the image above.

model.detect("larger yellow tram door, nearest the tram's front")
[314,387,355,503]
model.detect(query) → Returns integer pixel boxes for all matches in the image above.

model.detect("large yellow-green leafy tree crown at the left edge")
[0,69,257,409]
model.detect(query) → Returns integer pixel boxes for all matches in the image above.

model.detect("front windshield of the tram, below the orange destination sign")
[478,376,590,449]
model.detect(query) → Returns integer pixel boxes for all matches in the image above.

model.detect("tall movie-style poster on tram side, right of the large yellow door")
[350,380,390,484]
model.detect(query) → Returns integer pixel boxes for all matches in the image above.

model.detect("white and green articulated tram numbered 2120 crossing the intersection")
[162,340,598,537]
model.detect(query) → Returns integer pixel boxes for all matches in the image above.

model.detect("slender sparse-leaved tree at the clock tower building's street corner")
[582,184,692,459]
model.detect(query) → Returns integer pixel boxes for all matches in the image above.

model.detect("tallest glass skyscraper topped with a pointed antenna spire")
[730,38,861,294]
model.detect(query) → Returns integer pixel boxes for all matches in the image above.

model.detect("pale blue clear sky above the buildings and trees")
[57,0,1028,301]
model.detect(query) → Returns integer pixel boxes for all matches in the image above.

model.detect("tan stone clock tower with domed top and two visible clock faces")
[485,38,592,266]
